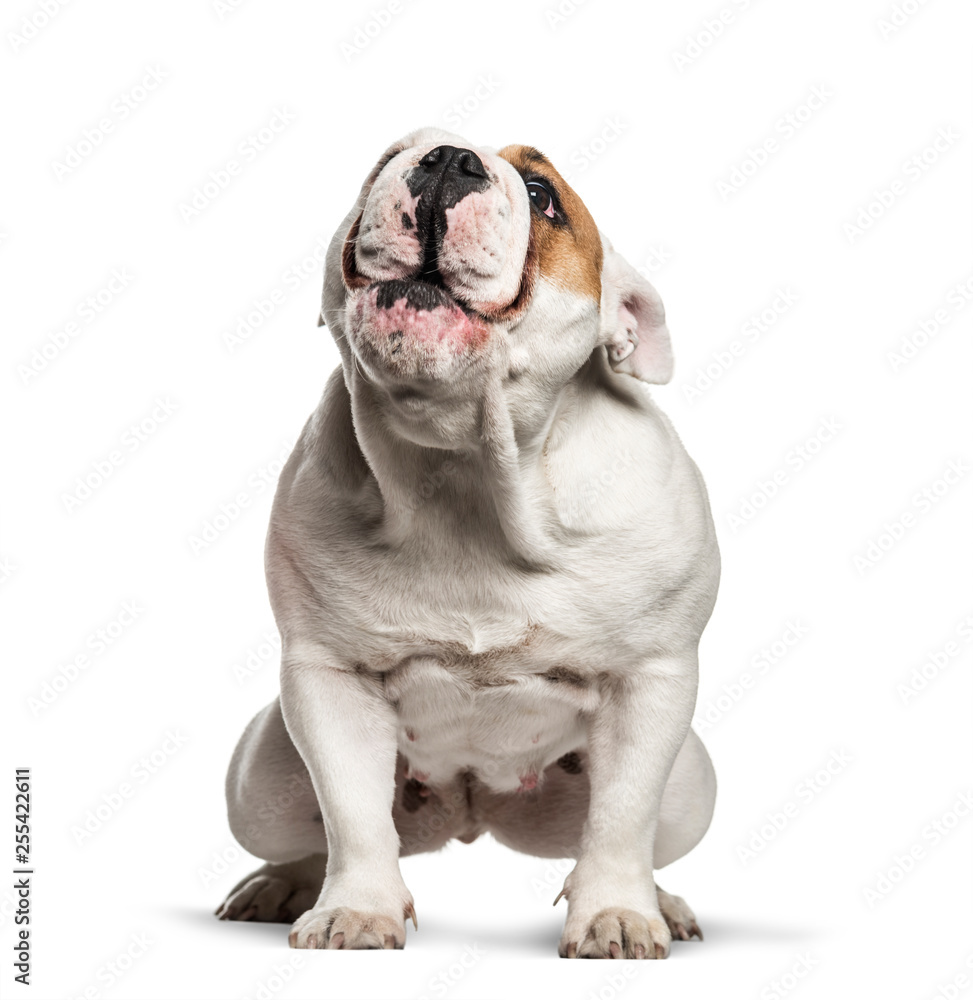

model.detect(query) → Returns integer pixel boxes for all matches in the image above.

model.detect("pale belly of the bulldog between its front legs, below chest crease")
[385,657,599,792]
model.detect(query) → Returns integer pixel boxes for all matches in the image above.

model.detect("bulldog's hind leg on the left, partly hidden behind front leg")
[216,700,467,923]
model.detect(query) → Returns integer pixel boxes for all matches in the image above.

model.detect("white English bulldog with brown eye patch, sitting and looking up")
[217,128,719,959]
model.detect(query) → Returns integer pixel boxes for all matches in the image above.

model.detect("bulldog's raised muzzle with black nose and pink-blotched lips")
[342,145,530,381]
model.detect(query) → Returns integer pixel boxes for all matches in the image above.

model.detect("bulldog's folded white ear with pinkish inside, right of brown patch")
[598,237,672,385]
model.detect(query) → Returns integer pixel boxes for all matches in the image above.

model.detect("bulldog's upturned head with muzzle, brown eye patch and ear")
[322,128,672,447]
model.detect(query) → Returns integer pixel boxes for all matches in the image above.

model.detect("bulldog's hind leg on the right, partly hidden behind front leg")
[476,730,716,957]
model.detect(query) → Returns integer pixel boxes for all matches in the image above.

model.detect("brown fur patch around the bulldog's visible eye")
[498,145,602,302]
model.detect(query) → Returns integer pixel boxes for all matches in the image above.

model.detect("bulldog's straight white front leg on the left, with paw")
[281,646,415,949]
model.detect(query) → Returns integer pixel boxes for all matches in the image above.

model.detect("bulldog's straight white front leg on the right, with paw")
[555,649,697,958]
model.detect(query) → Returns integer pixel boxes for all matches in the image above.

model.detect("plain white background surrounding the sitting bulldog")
[0,0,973,1000]
